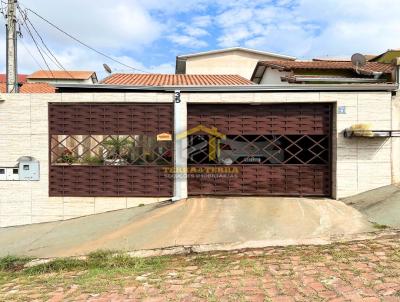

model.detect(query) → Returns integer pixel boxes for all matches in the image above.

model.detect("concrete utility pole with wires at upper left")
[6,0,18,93]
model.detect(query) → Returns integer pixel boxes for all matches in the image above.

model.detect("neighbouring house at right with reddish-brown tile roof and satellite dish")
[251,60,396,85]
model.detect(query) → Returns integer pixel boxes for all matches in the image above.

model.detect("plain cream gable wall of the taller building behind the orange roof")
[186,50,290,79]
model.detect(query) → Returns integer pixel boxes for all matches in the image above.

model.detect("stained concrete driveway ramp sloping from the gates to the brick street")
[0,197,374,257]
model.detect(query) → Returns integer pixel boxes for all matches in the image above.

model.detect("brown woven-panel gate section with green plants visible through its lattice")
[49,103,173,197]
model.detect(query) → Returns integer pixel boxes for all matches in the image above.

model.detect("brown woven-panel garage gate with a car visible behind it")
[188,104,332,196]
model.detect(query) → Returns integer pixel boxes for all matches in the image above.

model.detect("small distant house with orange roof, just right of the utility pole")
[26,70,98,84]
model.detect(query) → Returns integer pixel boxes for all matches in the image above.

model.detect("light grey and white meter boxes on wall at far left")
[0,156,40,181]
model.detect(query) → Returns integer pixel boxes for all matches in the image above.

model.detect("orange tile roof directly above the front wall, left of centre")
[101,73,254,86]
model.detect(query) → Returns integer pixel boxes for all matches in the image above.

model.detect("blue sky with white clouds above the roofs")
[0,0,400,77]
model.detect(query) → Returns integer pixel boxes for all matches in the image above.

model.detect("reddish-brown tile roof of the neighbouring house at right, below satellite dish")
[258,61,394,73]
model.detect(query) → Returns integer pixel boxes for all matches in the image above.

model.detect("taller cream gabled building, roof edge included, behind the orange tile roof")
[175,47,296,79]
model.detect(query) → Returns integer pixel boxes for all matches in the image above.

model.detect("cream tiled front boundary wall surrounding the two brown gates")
[0,92,399,227]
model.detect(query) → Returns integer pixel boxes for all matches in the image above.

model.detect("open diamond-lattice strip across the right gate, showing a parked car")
[188,134,329,165]
